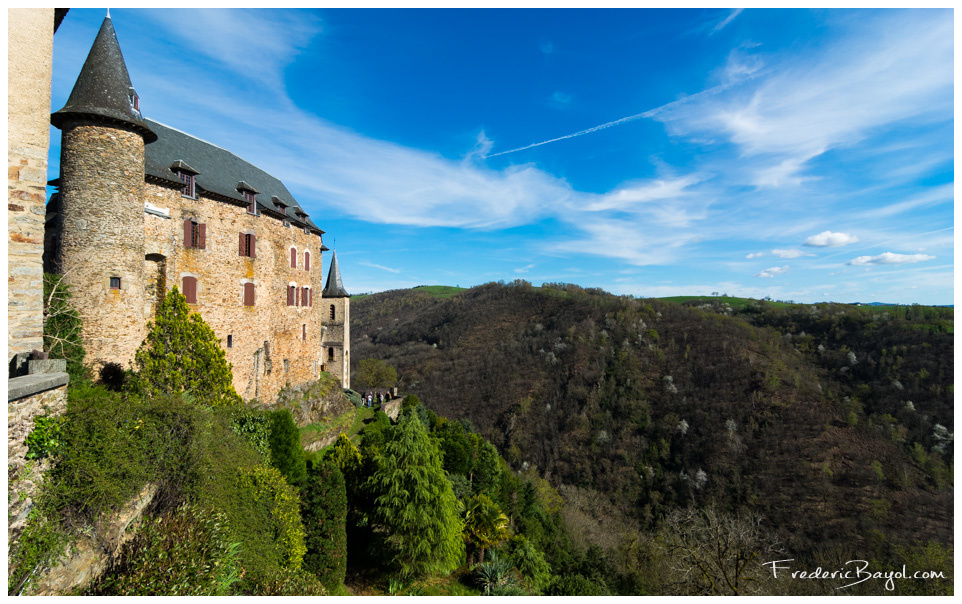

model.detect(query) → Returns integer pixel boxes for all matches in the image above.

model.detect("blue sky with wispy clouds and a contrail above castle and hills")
[50,9,954,304]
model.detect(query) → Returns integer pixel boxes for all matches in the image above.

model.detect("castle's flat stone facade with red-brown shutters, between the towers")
[141,183,326,404]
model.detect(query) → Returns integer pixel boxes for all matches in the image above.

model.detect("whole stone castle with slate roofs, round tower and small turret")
[44,15,350,402]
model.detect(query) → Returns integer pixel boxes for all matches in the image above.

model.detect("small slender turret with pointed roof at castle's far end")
[321,251,351,388]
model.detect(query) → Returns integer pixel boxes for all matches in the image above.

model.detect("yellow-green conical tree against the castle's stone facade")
[134,285,241,405]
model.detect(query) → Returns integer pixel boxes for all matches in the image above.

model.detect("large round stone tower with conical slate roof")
[50,16,157,366]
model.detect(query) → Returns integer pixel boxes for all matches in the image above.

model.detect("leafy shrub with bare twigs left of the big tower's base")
[43,273,88,383]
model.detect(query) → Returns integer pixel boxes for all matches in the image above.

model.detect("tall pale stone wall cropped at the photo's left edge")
[7,8,54,363]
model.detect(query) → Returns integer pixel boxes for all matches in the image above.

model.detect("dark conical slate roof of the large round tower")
[50,16,157,143]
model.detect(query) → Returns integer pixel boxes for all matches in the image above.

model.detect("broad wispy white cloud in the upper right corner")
[656,11,954,186]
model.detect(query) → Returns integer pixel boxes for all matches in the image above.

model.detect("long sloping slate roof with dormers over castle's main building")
[144,120,326,235]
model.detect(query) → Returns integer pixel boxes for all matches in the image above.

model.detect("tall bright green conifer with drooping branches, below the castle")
[368,415,464,577]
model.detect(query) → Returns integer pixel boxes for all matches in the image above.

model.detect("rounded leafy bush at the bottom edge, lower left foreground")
[86,505,240,596]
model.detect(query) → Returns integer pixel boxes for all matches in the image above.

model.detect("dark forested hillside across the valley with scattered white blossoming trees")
[352,282,954,596]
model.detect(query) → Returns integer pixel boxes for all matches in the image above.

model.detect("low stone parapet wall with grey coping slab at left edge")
[7,374,67,544]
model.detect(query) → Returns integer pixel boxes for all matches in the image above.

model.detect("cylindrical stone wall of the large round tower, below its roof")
[58,123,145,366]
